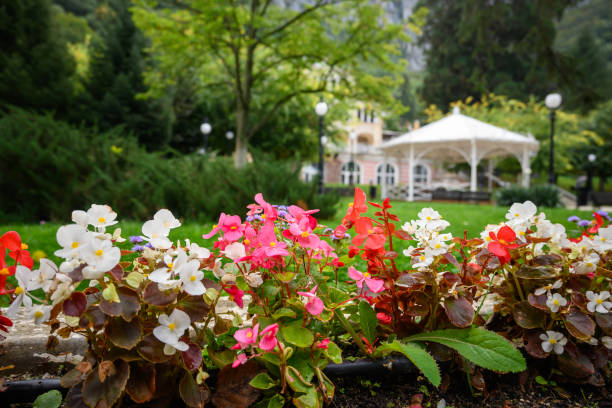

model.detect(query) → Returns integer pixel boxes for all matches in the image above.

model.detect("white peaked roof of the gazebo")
[379,107,540,162]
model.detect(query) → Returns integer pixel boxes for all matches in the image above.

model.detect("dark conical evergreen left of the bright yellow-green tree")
[73,0,171,149]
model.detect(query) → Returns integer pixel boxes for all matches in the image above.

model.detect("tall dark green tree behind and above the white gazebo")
[421,0,575,110]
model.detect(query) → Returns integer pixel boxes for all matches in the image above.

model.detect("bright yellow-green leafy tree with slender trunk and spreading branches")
[132,0,403,167]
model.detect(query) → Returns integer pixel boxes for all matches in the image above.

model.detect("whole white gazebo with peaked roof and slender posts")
[379,107,540,201]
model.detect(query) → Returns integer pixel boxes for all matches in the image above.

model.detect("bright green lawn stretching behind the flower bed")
[0,198,591,268]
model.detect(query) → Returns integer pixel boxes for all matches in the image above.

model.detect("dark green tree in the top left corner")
[0,0,74,115]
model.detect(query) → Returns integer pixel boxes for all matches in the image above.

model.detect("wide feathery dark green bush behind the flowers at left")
[0,109,337,222]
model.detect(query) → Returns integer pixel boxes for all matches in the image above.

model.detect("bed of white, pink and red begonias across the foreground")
[0,189,612,407]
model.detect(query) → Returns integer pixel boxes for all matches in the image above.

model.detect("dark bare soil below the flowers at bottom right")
[331,372,612,408]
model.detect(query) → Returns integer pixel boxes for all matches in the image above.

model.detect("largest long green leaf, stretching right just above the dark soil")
[405,327,527,373]
